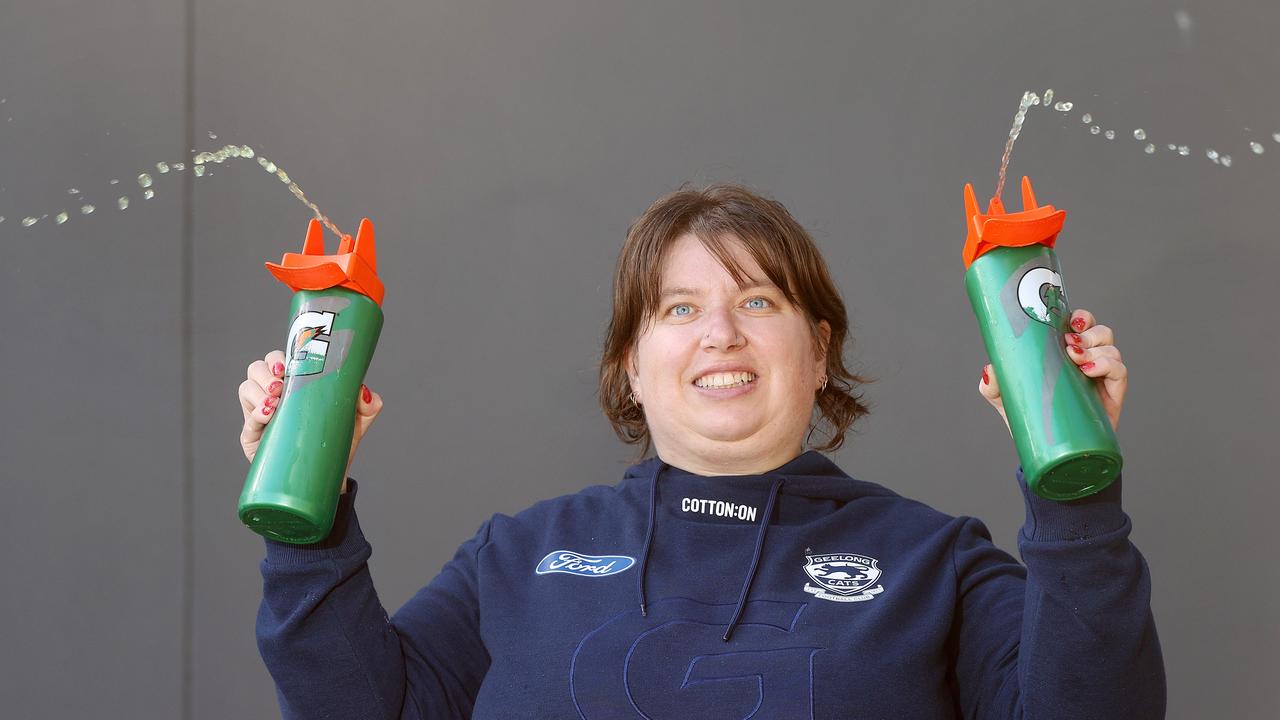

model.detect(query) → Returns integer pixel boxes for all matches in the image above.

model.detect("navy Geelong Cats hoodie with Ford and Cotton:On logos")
[257,451,1165,720]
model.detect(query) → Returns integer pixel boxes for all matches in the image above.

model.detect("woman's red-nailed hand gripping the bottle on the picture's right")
[978,303,1129,429]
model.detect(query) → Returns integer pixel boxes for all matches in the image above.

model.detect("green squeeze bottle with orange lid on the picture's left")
[239,218,384,544]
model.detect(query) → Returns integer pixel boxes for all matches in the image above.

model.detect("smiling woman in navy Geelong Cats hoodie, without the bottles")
[239,184,1165,720]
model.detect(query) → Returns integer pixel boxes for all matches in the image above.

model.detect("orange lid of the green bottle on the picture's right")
[964,176,1066,270]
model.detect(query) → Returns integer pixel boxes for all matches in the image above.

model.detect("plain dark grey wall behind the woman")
[0,0,1280,719]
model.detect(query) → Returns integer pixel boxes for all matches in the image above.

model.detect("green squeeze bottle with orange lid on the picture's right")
[964,177,1123,500]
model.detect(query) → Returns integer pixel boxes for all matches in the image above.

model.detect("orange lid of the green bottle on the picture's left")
[266,212,385,305]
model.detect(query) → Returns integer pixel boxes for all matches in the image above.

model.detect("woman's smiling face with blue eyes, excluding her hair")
[628,234,831,474]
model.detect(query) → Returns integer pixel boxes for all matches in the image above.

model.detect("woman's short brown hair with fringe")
[600,183,872,456]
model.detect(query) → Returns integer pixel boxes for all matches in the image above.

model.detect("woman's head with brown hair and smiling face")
[600,183,870,474]
